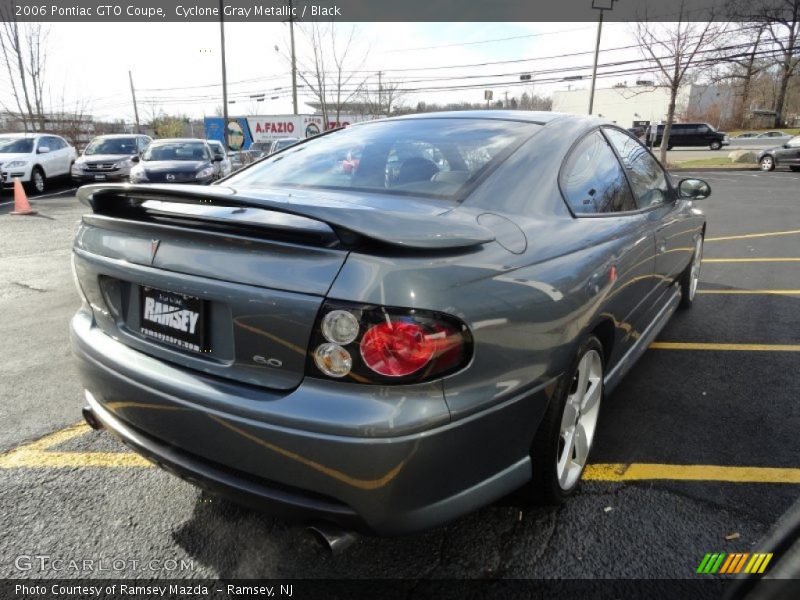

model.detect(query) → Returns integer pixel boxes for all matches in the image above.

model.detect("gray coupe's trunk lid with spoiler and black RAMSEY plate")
[74,185,492,390]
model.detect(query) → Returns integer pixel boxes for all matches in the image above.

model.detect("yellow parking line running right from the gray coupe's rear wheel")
[583,463,800,484]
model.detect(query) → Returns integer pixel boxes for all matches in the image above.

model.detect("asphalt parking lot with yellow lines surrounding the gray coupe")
[0,171,800,579]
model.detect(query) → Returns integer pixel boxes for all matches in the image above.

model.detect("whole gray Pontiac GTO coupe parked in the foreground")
[71,111,710,534]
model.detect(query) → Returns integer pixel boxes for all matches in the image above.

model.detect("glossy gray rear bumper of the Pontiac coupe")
[71,312,547,534]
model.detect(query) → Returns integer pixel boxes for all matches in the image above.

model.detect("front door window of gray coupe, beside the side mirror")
[605,129,670,208]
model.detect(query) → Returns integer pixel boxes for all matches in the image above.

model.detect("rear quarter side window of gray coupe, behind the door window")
[561,131,636,215]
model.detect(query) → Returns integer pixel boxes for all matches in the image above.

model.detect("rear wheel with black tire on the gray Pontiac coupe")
[524,336,604,504]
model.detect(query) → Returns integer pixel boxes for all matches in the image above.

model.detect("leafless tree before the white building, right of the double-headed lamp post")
[634,1,726,163]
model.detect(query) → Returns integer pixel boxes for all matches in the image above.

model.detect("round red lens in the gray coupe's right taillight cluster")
[361,322,441,377]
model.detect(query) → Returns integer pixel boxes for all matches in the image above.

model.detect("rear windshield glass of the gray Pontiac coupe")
[225,118,540,198]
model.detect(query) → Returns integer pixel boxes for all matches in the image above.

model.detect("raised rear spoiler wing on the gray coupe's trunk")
[77,184,495,250]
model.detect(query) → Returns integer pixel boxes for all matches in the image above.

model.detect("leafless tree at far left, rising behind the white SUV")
[0,3,47,131]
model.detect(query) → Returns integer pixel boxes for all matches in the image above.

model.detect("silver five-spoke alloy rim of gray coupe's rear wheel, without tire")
[556,350,603,490]
